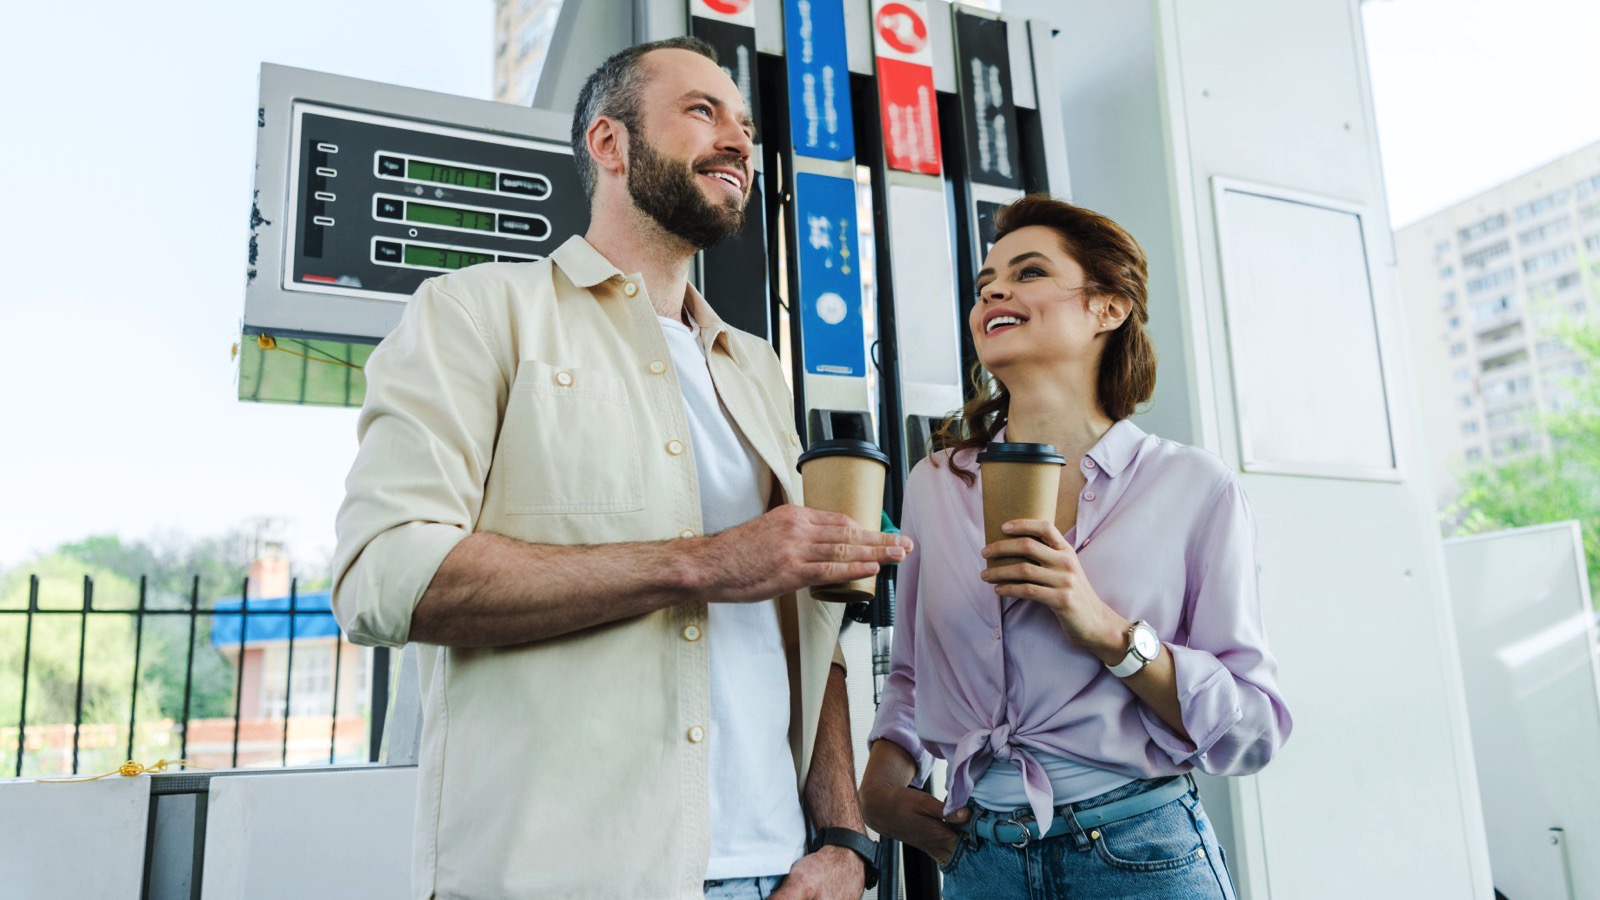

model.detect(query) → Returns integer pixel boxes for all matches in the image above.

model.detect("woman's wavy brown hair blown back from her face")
[933,194,1155,485]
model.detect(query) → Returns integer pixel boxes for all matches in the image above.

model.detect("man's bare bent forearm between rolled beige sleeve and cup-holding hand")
[410,532,694,647]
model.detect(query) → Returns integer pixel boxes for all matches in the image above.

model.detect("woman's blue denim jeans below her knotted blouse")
[939,781,1235,900]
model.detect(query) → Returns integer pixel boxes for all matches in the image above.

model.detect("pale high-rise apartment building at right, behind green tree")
[1395,143,1600,503]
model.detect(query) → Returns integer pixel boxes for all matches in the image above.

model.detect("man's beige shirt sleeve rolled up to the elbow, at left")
[333,280,507,647]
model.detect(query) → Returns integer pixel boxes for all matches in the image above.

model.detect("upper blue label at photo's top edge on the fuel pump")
[784,0,856,160]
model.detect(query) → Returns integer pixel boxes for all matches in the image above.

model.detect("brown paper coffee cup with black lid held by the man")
[800,439,890,604]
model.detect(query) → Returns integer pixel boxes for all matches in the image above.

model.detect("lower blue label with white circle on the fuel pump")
[795,171,867,378]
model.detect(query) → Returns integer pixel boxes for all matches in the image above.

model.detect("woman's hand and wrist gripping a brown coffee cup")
[982,519,1130,665]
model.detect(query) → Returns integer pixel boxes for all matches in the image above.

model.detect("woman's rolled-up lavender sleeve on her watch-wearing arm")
[1139,476,1293,775]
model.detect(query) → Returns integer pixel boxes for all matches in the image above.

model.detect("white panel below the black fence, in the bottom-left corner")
[0,775,150,900]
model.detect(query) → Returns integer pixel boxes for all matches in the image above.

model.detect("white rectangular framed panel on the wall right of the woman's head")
[1214,178,1397,479]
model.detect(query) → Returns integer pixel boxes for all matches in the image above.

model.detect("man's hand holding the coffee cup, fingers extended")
[698,504,910,602]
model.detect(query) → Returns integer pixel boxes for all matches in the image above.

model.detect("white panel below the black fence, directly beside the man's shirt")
[200,767,416,900]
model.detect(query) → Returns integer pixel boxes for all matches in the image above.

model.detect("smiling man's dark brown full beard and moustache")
[627,131,749,250]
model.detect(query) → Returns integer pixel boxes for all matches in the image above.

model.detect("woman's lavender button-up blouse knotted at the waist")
[870,420,1293,828]
